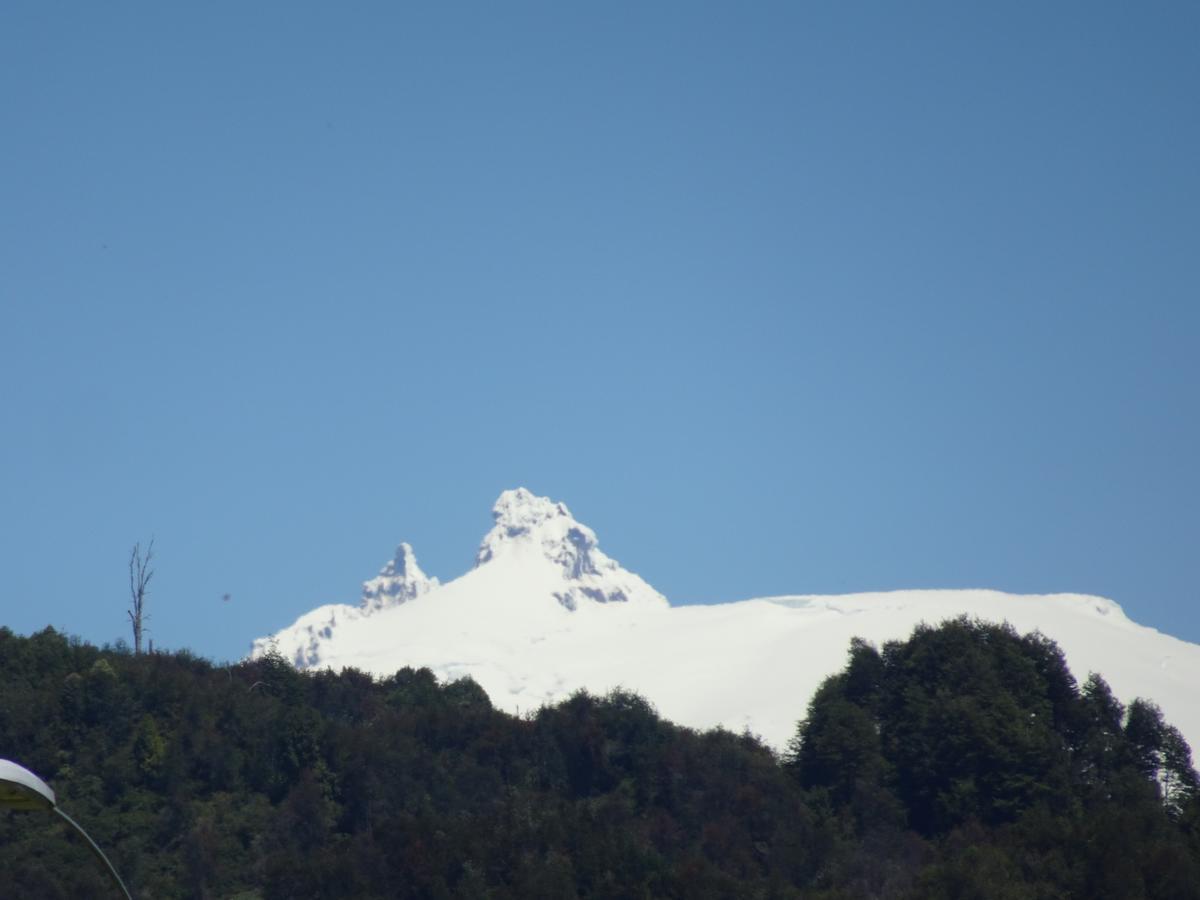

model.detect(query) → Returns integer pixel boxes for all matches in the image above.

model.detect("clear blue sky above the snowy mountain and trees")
[0,0,1200,659]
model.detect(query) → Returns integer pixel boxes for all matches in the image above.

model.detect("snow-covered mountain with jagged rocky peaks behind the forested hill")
[252,488,1200,748]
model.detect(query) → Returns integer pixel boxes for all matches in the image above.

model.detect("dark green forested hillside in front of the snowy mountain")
[0,619,1200,900]
